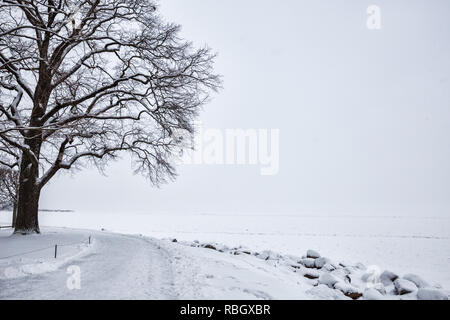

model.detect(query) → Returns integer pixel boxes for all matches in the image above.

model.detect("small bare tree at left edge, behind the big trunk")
[0,166,19,227]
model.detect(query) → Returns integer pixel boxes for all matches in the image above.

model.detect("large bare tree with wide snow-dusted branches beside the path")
[0,0,220,234]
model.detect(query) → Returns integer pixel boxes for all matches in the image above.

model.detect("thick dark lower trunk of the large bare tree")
[14,156,41,234]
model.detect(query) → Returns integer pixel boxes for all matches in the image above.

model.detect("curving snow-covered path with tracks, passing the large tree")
[0,232,176,299]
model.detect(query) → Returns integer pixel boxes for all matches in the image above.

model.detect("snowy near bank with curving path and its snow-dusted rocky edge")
[0,228,450,300]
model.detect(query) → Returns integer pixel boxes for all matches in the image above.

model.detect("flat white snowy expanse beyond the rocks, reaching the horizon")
[0,212,450,294]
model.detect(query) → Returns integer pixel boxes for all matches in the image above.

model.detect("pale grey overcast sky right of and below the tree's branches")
[41,0,450,215]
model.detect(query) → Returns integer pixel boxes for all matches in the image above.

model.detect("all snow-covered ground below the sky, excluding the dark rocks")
[0,212,450,299]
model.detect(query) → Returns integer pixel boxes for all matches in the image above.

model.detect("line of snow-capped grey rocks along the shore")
[171,239,449,300]
